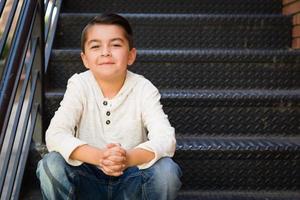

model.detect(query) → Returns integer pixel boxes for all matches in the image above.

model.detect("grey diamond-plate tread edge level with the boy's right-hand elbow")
[175,135,300,152]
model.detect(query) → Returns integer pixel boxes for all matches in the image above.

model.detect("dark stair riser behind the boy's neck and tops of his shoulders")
[48,59,300,89]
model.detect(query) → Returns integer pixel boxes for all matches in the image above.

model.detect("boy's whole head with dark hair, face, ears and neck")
[81,14,136,82]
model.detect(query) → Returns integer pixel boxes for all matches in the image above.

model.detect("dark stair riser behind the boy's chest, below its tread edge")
[45,95,300,137]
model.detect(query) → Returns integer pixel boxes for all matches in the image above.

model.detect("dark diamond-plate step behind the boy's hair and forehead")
[54,13,292,49]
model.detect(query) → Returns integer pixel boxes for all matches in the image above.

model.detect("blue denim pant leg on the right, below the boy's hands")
[114,157,182,200]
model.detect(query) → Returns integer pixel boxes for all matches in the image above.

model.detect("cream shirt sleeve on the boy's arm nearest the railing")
[46,75,86,165]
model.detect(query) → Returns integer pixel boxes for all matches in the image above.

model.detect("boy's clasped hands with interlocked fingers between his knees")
[99,143,128,176]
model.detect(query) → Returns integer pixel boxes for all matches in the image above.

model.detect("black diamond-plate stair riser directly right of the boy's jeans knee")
[175,151,300,191]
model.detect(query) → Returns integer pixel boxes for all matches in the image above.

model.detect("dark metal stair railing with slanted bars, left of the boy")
[0,0,62,199]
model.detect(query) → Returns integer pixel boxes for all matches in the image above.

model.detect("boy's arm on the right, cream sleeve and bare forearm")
[129,82,176,169]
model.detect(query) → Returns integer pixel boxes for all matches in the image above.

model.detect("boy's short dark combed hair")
[81,13,133,53]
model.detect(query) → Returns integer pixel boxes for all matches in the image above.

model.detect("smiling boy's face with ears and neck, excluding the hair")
[81,24,136,81]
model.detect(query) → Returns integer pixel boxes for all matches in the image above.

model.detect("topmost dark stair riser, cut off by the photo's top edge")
[62,0,282,14]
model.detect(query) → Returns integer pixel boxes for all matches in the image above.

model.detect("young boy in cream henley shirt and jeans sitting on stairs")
[37,14,181,200]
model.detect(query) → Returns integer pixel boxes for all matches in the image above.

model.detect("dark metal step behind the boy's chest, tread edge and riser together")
[44,90,300,136]
